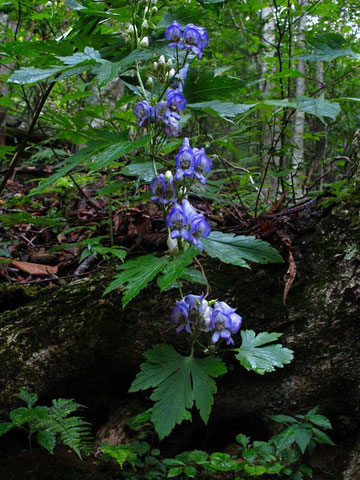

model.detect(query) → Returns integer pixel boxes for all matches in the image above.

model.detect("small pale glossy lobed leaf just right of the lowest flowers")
[236,330,293,375]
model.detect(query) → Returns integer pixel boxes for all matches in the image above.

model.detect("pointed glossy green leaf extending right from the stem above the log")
[202,232,283,268]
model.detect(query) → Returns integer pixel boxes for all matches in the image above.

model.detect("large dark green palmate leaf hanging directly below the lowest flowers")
[129,344,226,439]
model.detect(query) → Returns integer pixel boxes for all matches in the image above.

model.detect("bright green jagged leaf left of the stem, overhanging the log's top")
[103,255,168,307]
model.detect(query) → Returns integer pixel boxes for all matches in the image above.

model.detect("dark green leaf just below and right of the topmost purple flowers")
[183,68,242,104]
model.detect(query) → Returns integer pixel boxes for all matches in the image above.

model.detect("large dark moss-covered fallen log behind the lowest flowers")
[0,192,360,478]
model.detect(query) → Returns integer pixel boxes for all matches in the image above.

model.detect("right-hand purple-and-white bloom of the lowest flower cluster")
[211,302,242,345]
